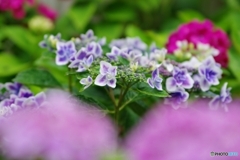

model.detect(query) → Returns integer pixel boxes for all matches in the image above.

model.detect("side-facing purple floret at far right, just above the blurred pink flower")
[210,83,232,111]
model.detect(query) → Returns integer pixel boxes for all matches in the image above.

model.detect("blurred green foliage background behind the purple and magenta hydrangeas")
[0,0,240,95]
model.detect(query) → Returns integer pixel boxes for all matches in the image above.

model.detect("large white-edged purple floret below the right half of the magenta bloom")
[194,57,222,91]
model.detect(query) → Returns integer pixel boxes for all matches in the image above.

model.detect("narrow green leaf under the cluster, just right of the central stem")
[136,82,169,97]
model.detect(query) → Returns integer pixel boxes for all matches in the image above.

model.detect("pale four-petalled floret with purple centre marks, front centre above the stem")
[95,61,117,88]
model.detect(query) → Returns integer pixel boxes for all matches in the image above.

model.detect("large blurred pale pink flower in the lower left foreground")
[0,92,117,160]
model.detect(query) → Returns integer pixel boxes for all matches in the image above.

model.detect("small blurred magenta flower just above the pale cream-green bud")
[37,4,57,21]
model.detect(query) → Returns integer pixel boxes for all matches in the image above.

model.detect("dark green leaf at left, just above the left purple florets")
[13,69,61,87]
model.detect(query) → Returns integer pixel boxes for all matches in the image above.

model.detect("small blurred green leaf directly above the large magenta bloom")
[177,10,205,22]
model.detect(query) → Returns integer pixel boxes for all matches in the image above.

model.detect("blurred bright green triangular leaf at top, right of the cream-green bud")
[68,3,97,31]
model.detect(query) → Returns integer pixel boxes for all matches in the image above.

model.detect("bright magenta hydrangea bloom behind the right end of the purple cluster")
[166,20,230,67]
